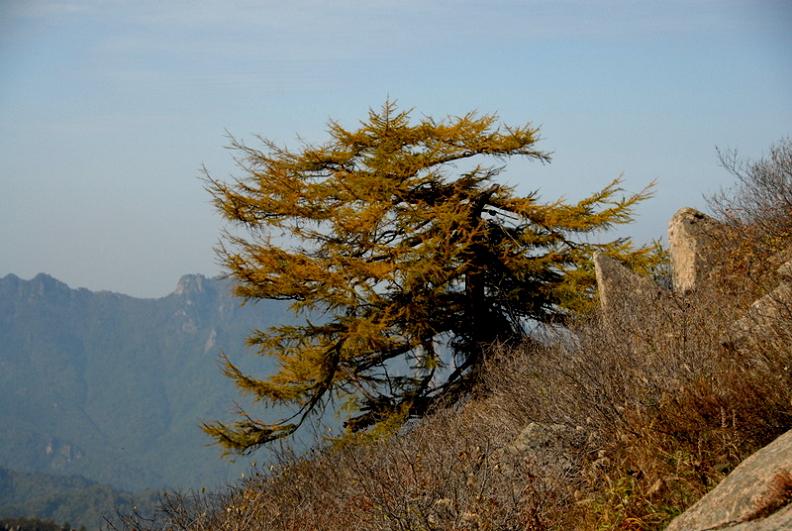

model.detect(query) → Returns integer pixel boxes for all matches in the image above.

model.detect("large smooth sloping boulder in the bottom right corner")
[667,431,792,531]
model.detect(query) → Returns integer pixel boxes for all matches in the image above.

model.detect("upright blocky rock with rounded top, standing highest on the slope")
[668,208,722,293]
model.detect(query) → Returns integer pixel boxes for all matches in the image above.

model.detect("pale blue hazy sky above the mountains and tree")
[0,0,792,296]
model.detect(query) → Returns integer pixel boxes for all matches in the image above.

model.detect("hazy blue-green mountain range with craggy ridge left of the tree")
[0,274,288,490]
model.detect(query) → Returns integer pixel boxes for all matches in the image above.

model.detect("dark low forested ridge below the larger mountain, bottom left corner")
[0,468,159,530]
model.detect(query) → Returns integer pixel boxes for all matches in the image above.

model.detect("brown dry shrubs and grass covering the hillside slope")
[129,141,792,530]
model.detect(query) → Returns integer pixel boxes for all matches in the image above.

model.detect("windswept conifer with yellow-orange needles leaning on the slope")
[204,101,649,452]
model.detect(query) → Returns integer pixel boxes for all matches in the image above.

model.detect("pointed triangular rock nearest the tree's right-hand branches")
[594,253,670,318]
